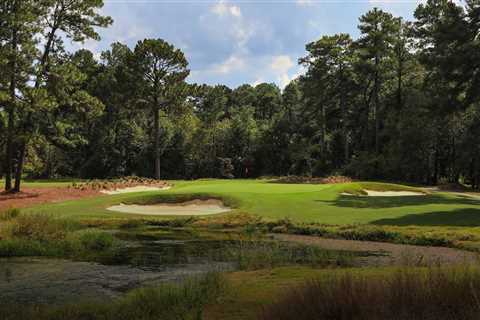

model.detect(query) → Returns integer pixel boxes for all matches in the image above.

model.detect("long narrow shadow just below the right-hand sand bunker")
[315,194,480,209]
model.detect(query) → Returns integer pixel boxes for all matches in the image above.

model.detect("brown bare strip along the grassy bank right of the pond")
[273,234,480,266]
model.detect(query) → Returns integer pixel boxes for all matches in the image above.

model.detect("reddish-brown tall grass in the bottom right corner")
[261,267,480,320]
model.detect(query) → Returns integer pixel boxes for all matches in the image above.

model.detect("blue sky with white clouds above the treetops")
[76,0,418,88]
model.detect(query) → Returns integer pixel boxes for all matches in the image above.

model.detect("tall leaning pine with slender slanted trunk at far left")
[9,0,112,191]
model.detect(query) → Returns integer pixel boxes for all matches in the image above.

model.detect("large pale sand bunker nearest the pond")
[107,199,231,216]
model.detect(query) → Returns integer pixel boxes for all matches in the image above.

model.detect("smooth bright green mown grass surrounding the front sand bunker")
[19,180,480,227]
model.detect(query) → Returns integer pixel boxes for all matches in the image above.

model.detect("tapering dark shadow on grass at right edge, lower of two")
[371,206,480,227]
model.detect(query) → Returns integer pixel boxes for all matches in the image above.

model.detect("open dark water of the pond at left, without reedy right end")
[0,228,234,304]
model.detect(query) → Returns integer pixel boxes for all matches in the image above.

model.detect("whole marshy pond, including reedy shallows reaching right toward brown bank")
[0,227,360,304]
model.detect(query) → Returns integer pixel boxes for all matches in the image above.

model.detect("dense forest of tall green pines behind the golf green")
[0,0,480,190]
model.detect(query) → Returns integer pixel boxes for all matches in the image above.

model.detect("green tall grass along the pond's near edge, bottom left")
[0,273,226,320]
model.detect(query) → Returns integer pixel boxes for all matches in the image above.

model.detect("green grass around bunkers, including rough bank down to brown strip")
[11,179,480,251]
